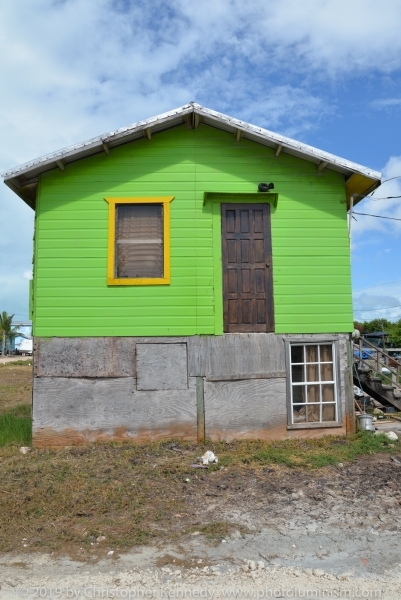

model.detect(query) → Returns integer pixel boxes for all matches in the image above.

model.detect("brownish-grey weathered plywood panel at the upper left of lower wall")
[34,337,136,377]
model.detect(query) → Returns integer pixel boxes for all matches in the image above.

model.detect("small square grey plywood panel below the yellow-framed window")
[136,344,188,390]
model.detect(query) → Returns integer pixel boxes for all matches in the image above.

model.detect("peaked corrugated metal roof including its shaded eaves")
[2,102,381,204]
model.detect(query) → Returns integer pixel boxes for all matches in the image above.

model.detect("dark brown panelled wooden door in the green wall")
[221,204,274,333]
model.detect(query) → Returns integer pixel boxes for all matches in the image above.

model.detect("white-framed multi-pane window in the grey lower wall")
[287,341,341,429]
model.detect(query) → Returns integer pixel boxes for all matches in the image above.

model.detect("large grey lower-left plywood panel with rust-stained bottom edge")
[33,377,197,446]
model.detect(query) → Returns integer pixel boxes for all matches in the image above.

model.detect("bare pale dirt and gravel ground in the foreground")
[0,451,401,598]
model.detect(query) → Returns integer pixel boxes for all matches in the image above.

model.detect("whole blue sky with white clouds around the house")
[0,0,401,320]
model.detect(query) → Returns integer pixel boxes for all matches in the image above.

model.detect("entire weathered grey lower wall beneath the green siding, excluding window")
[33,333,349,447]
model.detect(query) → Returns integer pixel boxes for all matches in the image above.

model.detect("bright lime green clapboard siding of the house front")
[31,125,352,337]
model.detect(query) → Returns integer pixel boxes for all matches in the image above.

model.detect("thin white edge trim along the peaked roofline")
[1,102,381,181]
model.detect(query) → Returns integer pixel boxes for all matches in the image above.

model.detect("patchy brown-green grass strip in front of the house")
[0,428,399,558]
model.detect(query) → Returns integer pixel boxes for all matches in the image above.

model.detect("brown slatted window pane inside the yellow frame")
[115,204,164,279]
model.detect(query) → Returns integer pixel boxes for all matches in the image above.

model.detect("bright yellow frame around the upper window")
[105,196,174,285]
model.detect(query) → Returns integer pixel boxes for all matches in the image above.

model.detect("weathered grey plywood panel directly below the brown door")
[188,333,285,381]
